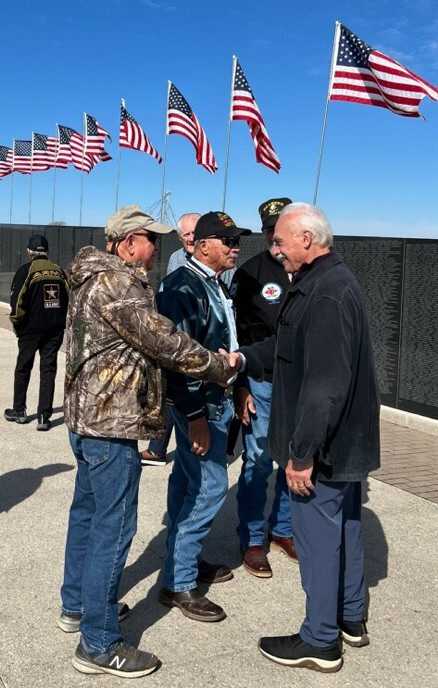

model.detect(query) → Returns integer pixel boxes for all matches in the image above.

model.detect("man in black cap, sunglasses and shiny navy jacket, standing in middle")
[157,212,250,622]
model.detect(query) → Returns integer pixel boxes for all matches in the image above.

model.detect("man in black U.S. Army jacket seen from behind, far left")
[4,235,68,430]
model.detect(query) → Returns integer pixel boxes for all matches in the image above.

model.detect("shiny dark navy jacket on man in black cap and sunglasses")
[157,258,234,420]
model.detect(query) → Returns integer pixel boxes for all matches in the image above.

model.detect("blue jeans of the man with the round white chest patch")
[237,378,292,549]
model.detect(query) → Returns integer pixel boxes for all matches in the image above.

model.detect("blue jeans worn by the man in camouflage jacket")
[61,432,141,654]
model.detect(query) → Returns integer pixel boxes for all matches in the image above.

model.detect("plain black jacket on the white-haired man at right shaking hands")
[242,252,380,481]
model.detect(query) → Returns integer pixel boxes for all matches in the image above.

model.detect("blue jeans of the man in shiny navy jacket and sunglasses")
[164,399,233,592]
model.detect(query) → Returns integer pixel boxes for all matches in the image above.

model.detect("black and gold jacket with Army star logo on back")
[10,257,68,336]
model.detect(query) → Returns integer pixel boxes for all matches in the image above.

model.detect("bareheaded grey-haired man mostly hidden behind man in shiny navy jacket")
[140,213,235,466]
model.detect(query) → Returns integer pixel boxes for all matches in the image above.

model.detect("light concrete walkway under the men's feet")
[0,316,438,688]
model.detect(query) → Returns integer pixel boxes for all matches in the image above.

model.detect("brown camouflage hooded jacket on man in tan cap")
[64,246,232,439]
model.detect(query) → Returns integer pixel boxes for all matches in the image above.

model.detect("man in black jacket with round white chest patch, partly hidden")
[231,198,296,578]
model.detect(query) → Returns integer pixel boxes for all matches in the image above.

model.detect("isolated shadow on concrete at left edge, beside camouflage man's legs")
[0,463,74,513]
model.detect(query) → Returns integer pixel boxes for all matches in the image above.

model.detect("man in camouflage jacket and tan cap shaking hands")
[58,206,233,677]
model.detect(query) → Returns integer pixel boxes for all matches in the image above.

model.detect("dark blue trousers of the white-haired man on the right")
[291,480,365,647]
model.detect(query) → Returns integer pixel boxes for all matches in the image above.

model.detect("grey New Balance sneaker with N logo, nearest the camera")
[71,640,160,678]
